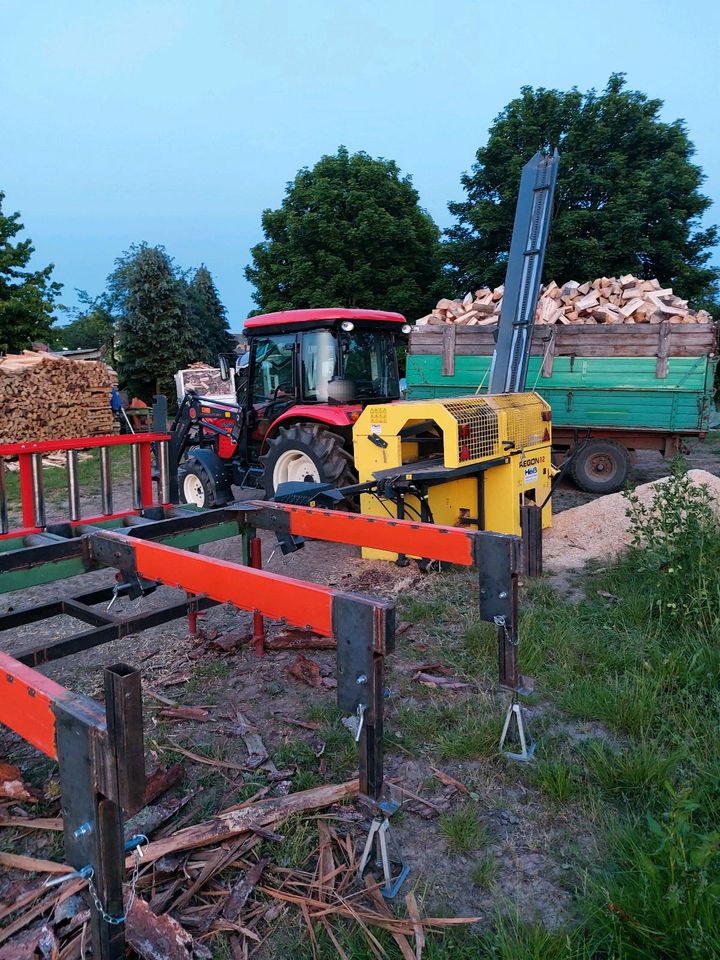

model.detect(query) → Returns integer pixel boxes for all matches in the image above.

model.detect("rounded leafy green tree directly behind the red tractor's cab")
[245,147,440,317]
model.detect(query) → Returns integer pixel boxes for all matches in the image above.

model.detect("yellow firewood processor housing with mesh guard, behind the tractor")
[353,393,554,559]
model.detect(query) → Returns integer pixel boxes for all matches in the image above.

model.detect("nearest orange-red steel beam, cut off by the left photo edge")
[0,653,105,760]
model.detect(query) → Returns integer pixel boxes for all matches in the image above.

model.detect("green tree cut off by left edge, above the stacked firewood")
[0,191,62,353]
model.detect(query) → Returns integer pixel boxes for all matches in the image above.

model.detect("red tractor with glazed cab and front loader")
[172,307,410,507]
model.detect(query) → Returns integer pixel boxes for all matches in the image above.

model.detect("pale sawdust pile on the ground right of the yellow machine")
[543,470,720,572]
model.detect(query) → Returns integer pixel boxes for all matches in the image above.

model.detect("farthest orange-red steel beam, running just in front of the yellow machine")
[247,501,475,566]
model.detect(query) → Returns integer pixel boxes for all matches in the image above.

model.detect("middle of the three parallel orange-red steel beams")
[128,532,337,637]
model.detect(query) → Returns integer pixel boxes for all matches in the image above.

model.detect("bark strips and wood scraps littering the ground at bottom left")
[0,768,478,960]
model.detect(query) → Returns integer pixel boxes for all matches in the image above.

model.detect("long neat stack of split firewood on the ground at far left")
[0,350,117,443]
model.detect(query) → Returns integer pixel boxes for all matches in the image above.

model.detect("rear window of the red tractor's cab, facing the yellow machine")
[340,330,400,400]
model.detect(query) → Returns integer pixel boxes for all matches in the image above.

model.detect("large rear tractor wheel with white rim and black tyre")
[260,423,357,497]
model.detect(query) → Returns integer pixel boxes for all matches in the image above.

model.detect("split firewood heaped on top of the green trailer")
[417,274,713,327]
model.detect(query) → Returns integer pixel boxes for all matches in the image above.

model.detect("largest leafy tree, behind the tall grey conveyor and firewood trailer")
[446,74,720,304]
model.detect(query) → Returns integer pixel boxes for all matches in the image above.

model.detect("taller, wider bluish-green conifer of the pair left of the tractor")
[108,244,197,402]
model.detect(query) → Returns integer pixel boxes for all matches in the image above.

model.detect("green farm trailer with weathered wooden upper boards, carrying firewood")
[407,321,719,493]
